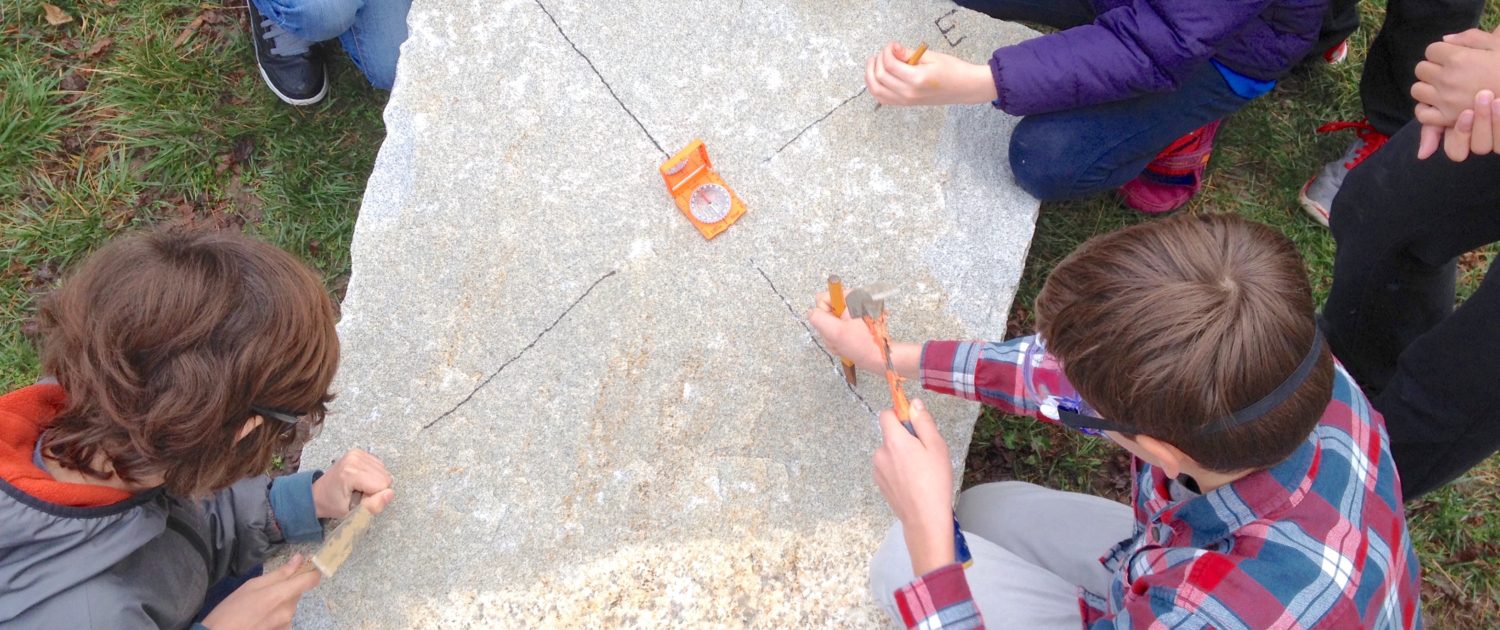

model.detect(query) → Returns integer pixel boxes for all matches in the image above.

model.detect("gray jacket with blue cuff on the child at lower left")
[0,473,323,630]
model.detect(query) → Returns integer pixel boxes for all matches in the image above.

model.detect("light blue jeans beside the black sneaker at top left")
[252,0,411,90]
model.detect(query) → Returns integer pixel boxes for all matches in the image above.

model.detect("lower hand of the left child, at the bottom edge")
[203,555,323,630]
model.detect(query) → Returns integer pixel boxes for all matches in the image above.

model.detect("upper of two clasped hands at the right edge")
[1412,29,1500,128]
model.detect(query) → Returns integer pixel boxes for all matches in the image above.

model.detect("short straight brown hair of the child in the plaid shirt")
[1037,215,1334,473]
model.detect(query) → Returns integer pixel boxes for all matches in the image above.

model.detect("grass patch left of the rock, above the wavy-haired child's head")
[0,0,386,387]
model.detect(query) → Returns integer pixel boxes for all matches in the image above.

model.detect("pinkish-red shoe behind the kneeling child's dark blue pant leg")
[1121,120,1220,215]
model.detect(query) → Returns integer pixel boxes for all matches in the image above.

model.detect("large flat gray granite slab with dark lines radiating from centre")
[299,0,1038,627]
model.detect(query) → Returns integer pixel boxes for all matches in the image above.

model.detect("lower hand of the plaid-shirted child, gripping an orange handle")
[875,401,956,575]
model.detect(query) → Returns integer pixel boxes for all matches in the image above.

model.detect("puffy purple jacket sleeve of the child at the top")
[990,0,1271,116]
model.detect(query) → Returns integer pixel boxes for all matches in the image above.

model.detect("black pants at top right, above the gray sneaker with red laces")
[1314,0,1485,135]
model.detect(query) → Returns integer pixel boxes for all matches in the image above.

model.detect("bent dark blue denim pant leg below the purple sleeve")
[1011,63,1250,201]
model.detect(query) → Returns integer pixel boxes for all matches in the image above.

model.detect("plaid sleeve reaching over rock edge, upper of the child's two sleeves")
[921,336,1062,422]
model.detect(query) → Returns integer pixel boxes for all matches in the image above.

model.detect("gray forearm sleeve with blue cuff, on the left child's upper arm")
[201,471,323,576]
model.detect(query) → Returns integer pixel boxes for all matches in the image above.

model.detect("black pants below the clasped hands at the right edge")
[1323,123,1500,501]
